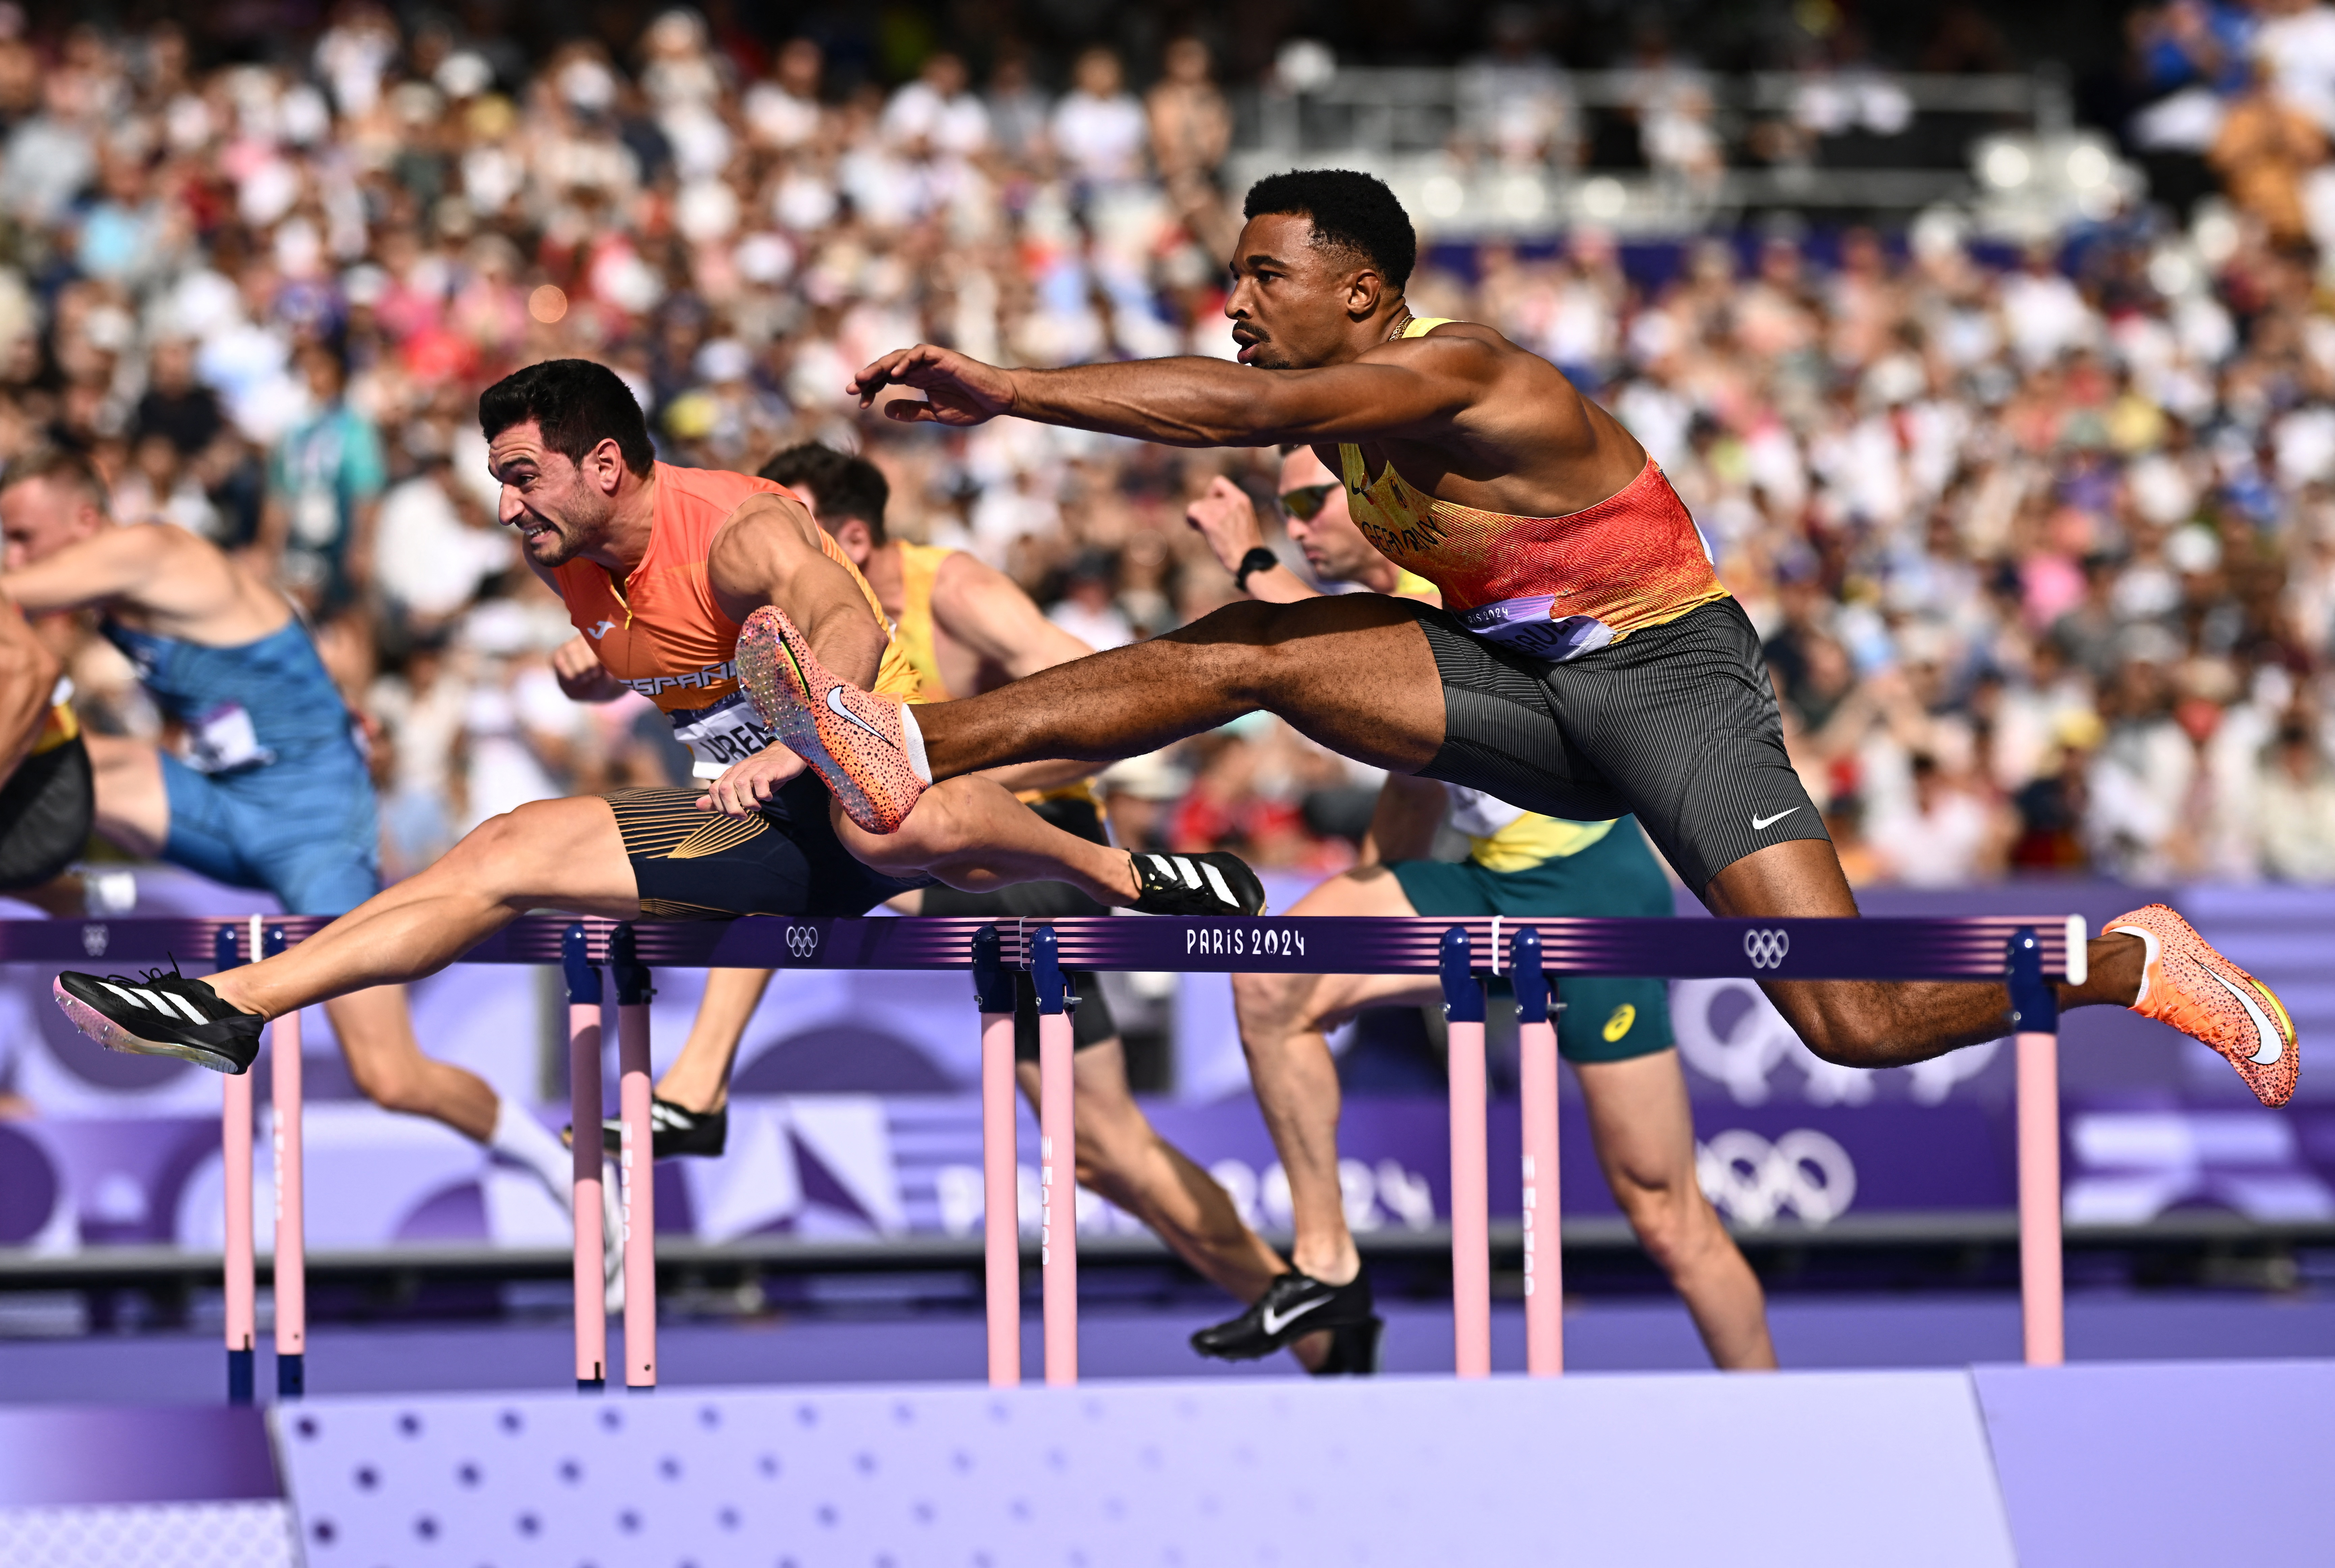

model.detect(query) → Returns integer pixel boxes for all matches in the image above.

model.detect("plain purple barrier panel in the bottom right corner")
[1973,1360,2335,1568]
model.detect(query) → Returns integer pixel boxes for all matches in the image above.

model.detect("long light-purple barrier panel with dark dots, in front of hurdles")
[276,1372,2013,1568]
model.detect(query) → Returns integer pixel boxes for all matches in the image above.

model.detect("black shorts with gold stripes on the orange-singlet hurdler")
[605,770,925,919]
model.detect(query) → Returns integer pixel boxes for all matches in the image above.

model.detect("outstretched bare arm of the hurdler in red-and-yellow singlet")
[852,331,1502,446]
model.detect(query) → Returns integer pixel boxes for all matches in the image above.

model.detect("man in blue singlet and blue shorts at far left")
[0,453,616,1267]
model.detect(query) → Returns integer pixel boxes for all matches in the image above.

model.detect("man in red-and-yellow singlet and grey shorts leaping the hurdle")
[745,170,2295,1129]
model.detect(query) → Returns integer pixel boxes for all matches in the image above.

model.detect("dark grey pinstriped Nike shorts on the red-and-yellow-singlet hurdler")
[1413,600,1828,896]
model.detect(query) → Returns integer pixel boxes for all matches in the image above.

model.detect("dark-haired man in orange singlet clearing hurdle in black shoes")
[56,359,1263,1073]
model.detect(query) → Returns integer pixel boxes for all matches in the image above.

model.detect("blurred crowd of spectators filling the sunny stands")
[0,0,2335,884]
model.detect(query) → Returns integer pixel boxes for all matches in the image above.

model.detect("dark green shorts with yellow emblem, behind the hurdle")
[1392,817,1677,1062]
